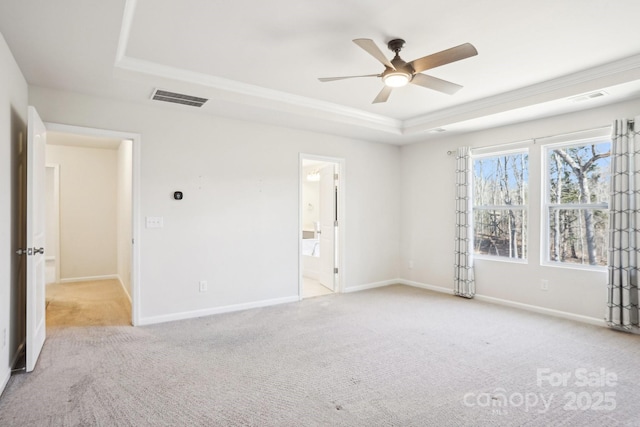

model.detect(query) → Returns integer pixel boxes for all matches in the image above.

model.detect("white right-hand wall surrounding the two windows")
[400,100,640,319]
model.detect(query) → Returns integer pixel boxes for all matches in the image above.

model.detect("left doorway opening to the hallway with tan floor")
[45,124,140,326]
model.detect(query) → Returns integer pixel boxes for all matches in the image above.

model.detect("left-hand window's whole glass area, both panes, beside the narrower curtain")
[473,150,529,260]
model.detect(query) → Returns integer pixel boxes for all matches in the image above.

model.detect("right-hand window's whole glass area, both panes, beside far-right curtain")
[544,139,611,266]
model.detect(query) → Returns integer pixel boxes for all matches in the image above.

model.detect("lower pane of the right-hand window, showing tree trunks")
[549,208,609,266]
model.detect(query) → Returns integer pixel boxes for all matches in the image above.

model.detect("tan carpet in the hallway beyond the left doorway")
[46,280,131,328]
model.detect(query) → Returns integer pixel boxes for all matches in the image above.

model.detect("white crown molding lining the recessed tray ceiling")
[114,0,640,143]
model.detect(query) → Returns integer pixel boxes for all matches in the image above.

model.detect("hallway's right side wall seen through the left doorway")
[116,140,133,300]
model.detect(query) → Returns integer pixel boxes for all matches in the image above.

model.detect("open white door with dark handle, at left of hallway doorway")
[26,107,46,372]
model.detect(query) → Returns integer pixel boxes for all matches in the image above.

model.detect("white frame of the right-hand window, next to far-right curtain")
[540,133,612,271]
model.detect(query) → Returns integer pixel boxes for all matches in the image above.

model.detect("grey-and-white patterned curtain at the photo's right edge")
[606,117,640,332]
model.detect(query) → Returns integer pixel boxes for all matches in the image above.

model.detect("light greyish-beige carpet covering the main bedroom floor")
[0,286,640,426]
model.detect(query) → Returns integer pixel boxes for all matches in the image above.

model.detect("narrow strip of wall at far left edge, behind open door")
[0,34,28,398]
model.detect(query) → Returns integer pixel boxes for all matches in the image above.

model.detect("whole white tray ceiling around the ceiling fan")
[0,0,640,144]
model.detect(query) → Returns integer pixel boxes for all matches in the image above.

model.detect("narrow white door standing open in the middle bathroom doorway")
[319,165,336,291]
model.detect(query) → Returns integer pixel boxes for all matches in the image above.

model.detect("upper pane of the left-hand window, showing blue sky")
[473,153,529,206]
